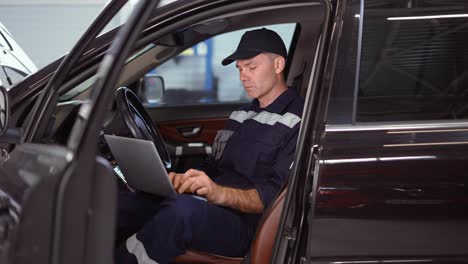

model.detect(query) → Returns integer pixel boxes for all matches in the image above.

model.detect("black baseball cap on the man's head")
[221,28,287,65]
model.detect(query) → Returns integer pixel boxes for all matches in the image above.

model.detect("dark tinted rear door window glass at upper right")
[356,0,468,122]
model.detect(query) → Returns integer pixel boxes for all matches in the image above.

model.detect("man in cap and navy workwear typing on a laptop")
[116,28,303,263]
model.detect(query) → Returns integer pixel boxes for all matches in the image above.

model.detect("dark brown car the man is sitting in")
[0,0,468,263]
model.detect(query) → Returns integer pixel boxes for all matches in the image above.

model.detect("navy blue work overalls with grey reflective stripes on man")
[115,89,303,264]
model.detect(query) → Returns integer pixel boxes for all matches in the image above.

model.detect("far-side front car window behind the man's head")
[143,23,296,107]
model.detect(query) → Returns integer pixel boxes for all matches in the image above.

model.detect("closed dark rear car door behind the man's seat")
[277,1,468,263]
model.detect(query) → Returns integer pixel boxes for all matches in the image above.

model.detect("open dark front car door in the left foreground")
[0,0,159,263]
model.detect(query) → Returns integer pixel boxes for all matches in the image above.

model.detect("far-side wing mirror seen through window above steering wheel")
[138,74,165,106]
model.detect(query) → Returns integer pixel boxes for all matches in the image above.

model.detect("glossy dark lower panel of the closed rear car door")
[309,127,468,259]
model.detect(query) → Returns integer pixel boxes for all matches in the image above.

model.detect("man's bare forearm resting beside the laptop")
[217,186,265,213]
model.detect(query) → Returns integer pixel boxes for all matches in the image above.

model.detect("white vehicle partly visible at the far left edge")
[0,23,37,89]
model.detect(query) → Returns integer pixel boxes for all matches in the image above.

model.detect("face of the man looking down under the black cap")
[236,53,277,101]
